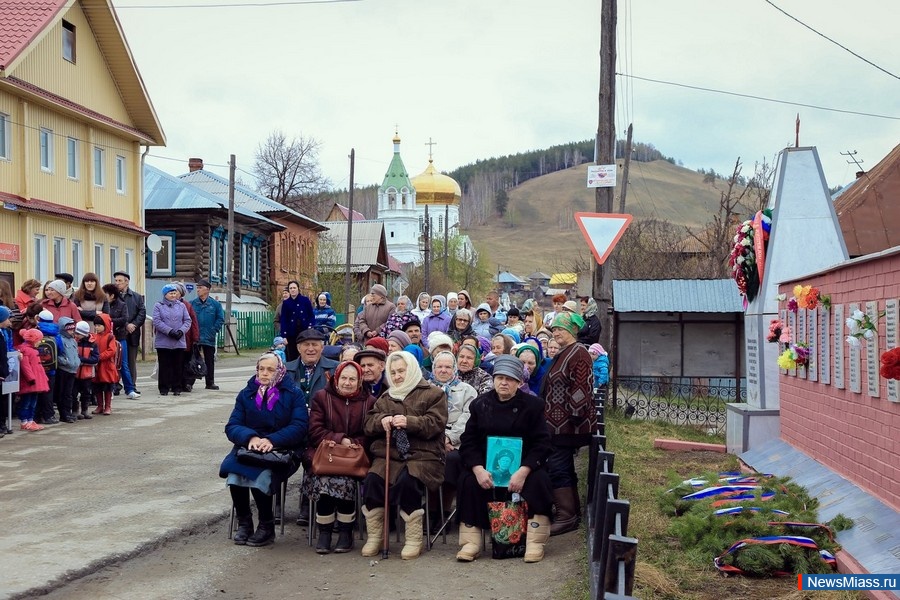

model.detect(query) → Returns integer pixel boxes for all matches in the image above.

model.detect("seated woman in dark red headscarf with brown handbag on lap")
[300,361,375,554]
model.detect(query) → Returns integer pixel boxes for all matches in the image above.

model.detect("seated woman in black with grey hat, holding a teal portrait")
[456,355,552,562]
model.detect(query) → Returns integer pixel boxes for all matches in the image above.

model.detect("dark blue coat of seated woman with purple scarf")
[219,377,309,488]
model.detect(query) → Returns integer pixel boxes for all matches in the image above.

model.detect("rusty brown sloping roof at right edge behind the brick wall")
[834,146,900,256]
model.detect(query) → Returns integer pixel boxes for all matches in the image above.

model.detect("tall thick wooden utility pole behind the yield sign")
[592,0,616,344]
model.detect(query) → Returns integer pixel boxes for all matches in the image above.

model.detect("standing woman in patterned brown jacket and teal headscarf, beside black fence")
[541,312,597,535]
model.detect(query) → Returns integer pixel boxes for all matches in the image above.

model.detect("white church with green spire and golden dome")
[378,133,475,264]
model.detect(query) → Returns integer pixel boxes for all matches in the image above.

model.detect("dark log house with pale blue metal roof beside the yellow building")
[144,165,286,310]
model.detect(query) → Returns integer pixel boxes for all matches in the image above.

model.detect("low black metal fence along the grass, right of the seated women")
[587,404,638,600]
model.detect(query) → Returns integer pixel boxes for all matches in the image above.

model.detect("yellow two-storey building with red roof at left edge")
[0,0,165,291]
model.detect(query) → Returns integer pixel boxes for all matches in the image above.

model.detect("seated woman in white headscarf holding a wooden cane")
[362,352,447,560]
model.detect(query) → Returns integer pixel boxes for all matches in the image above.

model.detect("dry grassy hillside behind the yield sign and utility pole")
[465,160,724,277]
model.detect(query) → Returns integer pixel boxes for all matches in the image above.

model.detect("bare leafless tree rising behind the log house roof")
[253,130,328,204]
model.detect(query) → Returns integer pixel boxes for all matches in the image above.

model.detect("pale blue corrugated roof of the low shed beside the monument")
[613,279,744,313]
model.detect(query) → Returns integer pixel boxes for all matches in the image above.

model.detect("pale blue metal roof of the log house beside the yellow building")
[144,164,285,230]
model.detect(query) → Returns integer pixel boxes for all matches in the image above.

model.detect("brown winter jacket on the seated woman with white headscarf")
[365,379,447,490]
